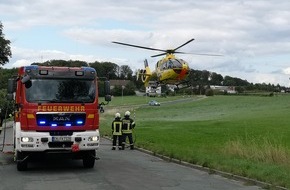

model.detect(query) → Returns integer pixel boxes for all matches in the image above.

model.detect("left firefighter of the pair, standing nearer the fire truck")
[112,113,122,150]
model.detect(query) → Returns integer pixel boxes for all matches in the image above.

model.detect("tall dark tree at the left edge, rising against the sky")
[0,22,12,66]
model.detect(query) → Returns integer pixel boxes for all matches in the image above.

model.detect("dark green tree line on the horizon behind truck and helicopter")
[0,60,286,95]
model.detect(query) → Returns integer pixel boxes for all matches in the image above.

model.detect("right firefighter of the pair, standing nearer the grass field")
[122,111,135,150]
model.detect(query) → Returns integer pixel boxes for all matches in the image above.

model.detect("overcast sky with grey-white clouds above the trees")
[0,0,290,86]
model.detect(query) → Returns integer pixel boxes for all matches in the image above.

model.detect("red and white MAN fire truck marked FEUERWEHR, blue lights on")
[7,65,111,171]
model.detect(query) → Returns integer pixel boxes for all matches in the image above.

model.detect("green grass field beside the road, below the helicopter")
[100,95,290,188]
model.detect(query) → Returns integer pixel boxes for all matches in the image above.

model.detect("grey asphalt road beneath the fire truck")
[0,122,261,190]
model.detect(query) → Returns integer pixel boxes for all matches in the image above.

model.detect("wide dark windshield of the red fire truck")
[25,79,96,103]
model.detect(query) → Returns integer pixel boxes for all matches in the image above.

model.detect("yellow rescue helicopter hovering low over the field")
[112,39,219,87]
